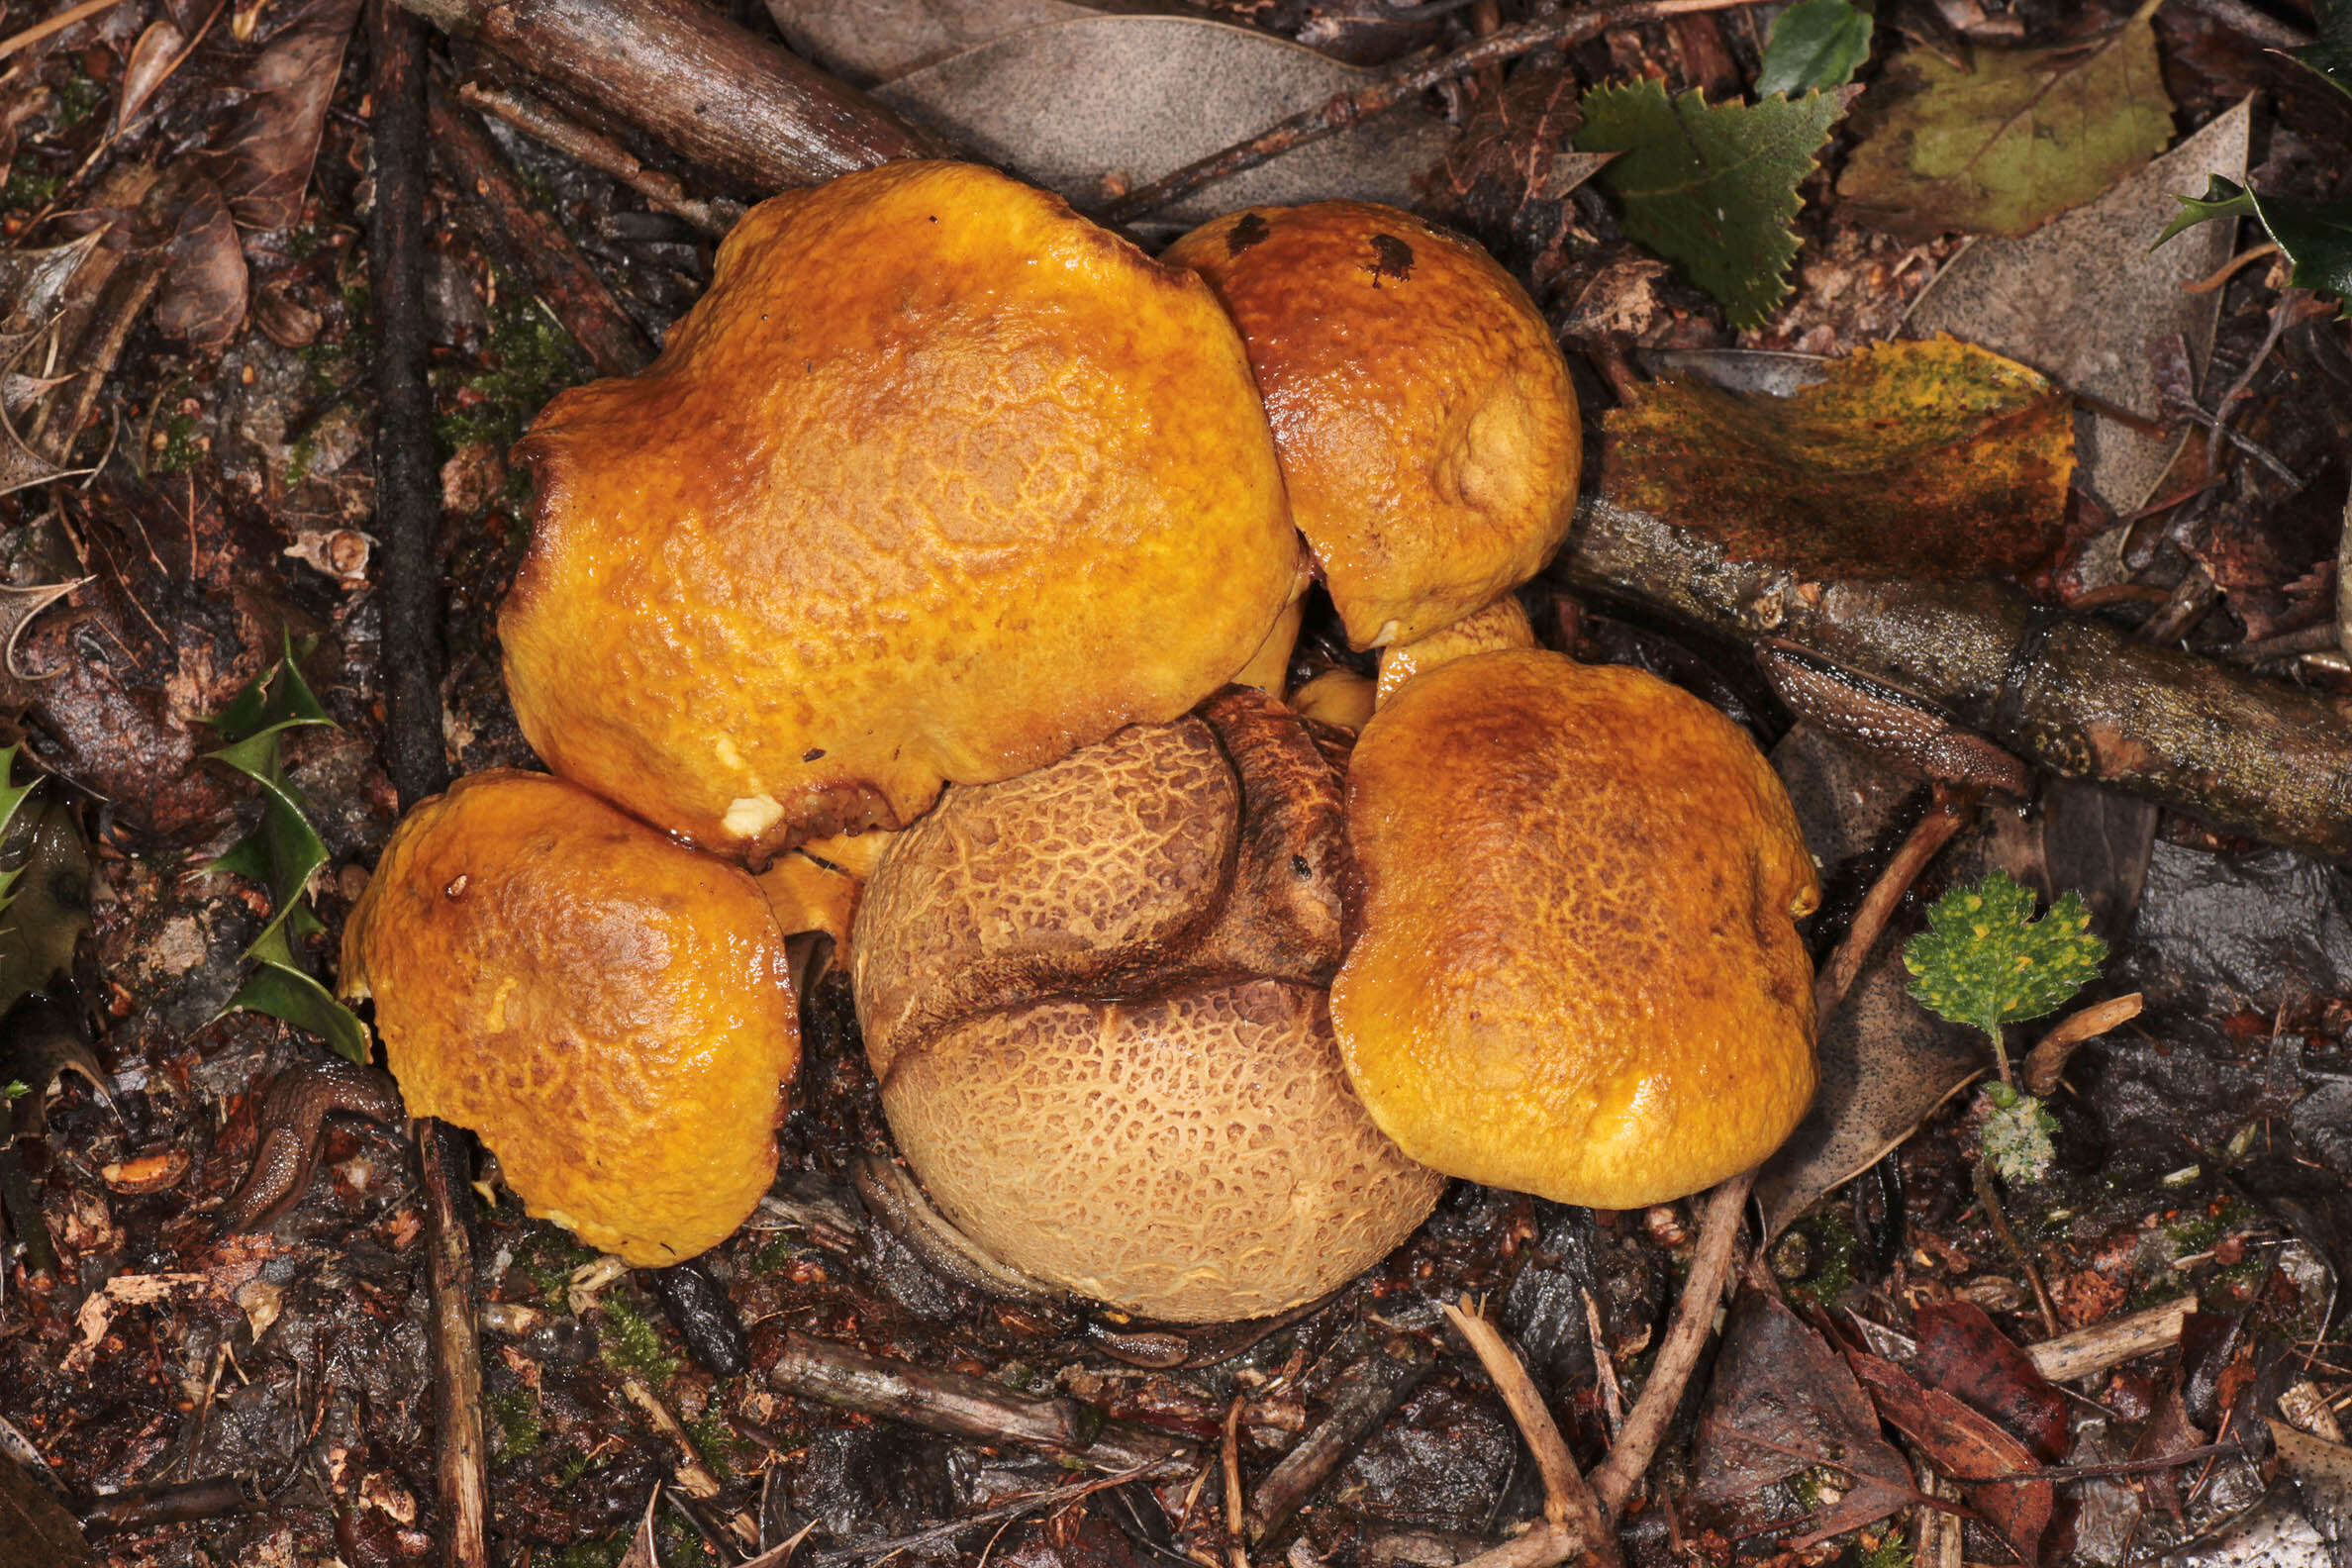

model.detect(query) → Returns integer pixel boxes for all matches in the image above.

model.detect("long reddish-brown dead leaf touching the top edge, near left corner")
[214,0,360,228]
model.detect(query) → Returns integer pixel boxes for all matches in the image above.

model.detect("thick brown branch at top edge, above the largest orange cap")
[402,0,948,190]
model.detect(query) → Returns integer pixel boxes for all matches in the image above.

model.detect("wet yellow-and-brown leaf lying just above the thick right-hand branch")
[1602,339,2075,581]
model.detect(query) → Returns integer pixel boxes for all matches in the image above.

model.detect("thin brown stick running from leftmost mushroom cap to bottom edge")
[409,1117,489,1568]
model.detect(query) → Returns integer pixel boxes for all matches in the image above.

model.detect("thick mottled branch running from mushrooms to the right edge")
[1555,501,2352,860]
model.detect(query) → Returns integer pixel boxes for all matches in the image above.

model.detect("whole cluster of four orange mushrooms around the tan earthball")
[343,162,1818,1322]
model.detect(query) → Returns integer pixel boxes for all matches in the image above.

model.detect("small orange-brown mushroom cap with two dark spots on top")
[1162,202,1583,648]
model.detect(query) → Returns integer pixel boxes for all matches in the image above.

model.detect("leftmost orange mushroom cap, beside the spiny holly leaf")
[343,771,800,1267]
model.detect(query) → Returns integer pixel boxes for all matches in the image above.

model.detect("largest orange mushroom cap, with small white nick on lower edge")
[499,162,1306,858]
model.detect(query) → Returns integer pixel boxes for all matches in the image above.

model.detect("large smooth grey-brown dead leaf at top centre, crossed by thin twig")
[875,17,1453,226]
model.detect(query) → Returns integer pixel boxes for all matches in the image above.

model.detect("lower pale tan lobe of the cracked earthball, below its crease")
[882,980,1444,1322]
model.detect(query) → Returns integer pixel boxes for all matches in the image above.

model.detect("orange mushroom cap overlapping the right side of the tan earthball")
[1331,648,1820,1209]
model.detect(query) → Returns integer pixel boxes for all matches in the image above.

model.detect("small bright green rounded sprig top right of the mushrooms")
[1903,872,2107,1039]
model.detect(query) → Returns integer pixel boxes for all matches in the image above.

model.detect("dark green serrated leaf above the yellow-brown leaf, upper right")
[1576,80,1844,327]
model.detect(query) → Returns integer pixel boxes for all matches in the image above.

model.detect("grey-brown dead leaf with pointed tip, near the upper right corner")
[1903,101,2253,513]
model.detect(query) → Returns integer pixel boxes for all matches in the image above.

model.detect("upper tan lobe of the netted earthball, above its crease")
[851,717,1242,1074]
